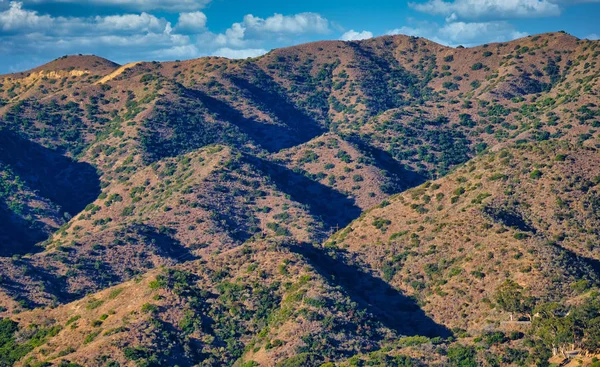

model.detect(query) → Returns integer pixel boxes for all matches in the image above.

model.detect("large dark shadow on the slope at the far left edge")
[0,129,100,215]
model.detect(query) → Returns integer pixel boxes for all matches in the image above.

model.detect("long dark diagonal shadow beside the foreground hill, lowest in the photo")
[287,244,452,337]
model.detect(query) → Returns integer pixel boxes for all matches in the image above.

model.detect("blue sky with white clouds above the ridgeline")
[0,0,600,73]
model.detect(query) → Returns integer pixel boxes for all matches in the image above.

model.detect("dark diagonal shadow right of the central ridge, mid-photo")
[246,156,361,229]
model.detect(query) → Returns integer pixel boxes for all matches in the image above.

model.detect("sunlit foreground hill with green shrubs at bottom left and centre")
[9,242,446,366]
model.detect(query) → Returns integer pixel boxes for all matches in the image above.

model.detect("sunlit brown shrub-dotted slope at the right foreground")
[325,142,600,330]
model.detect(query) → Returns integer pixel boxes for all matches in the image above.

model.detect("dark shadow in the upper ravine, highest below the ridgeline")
[230,73,325,150]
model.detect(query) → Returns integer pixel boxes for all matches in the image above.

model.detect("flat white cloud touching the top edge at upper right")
[409,0,566,21]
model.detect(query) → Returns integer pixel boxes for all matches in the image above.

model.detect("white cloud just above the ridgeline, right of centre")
[387,21,527,47]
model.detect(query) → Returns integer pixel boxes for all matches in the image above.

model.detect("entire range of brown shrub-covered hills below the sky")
[0,32,600,367]
